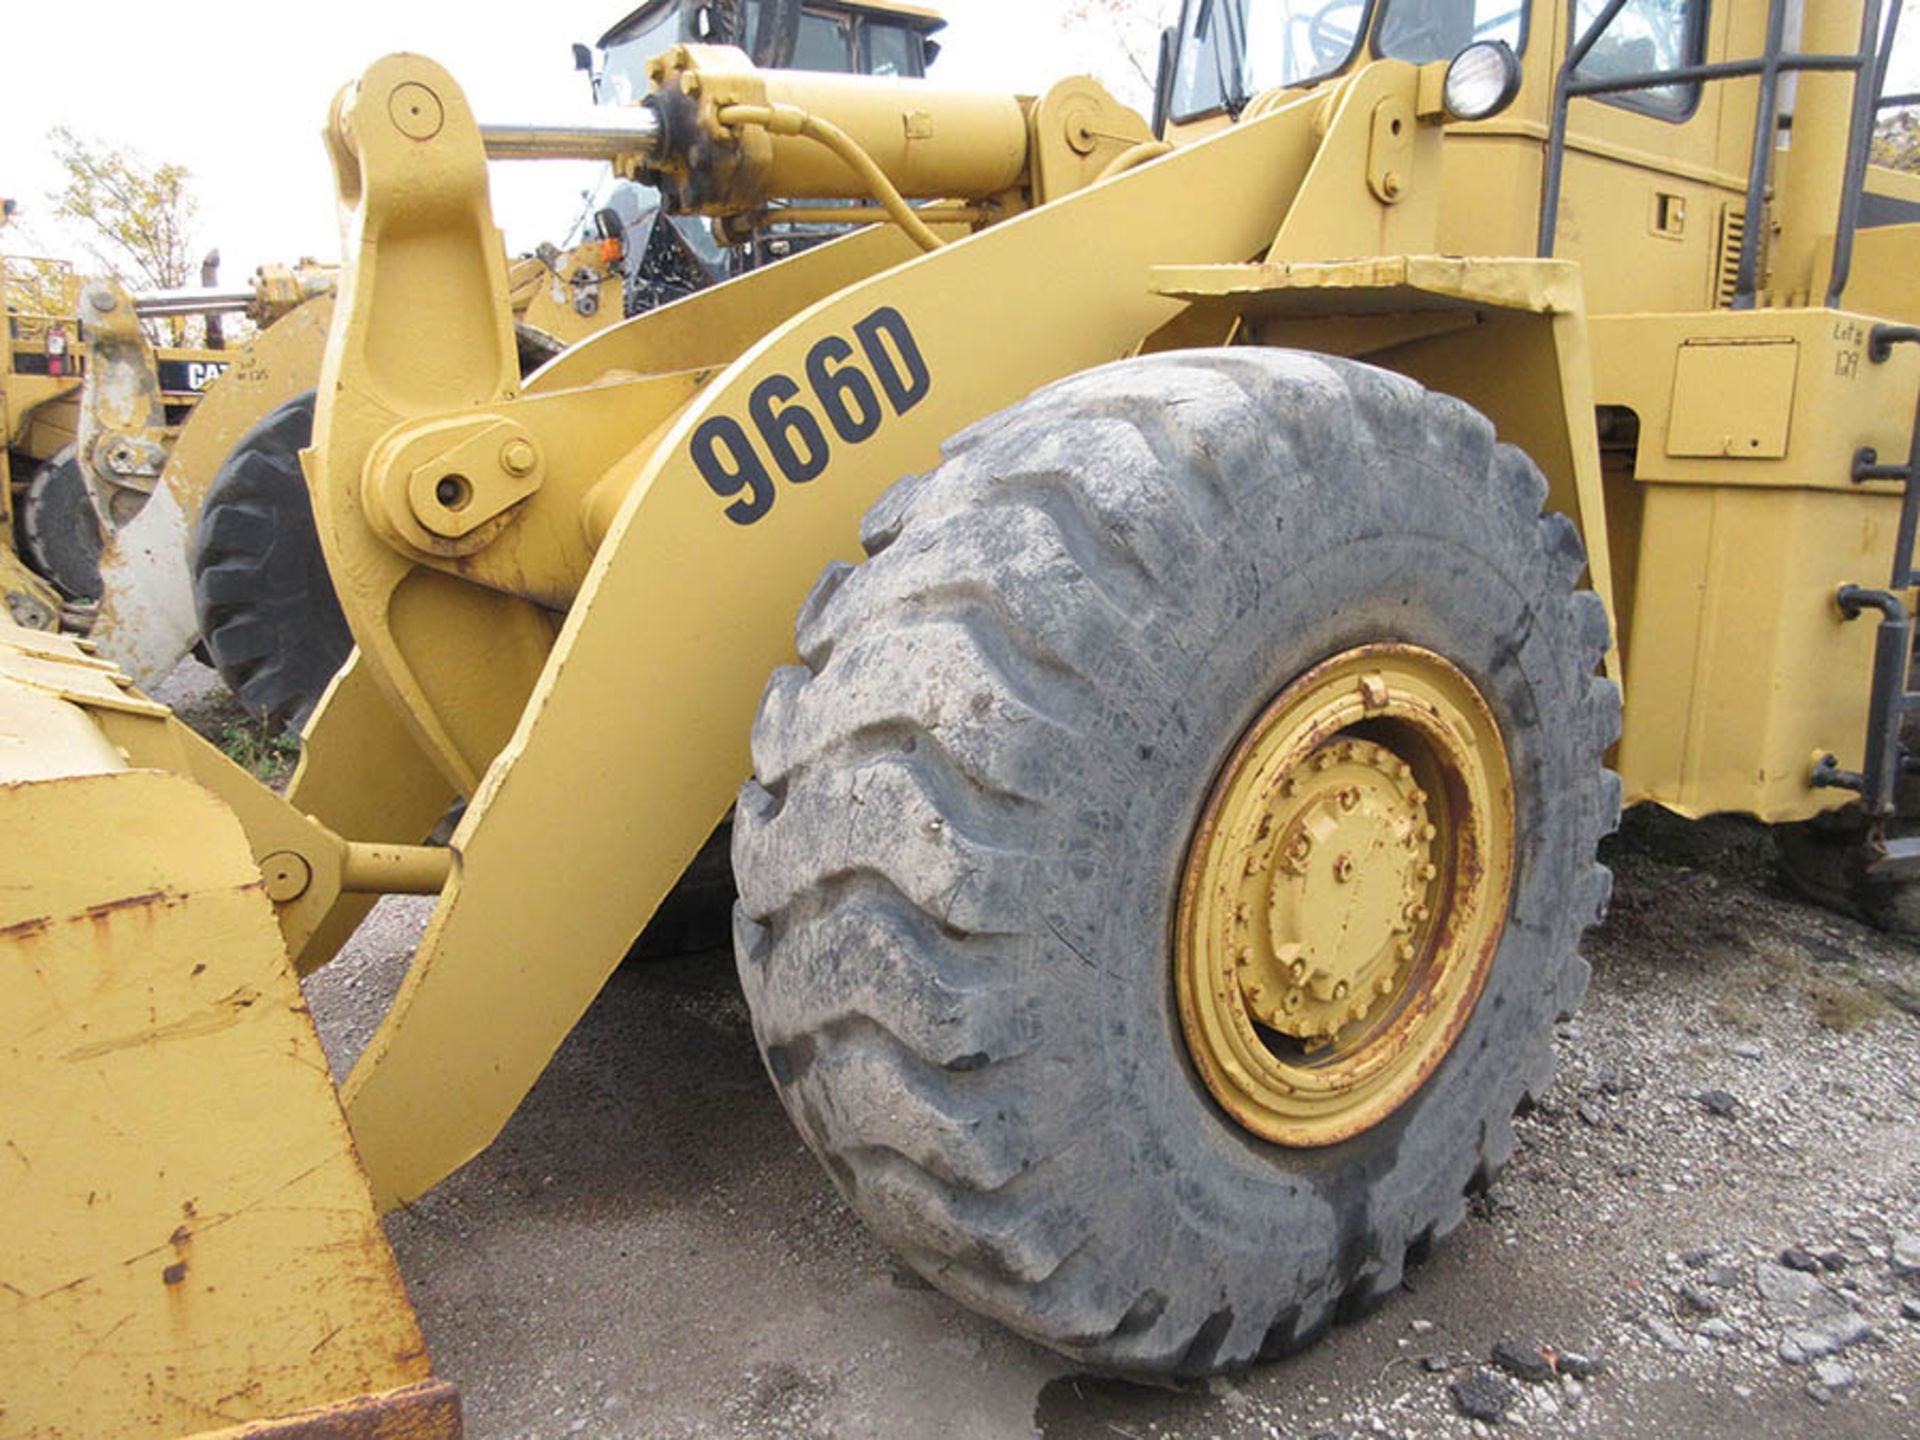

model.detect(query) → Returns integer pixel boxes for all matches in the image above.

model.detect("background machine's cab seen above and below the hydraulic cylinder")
[572,0,947,305]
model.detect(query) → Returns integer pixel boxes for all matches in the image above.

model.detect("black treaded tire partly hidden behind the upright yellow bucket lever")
[194,390,353,730]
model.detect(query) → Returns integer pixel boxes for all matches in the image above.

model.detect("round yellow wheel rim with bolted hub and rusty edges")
[1173,645,1513,1146]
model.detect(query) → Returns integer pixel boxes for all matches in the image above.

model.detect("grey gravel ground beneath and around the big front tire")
[161,664,1920,1440]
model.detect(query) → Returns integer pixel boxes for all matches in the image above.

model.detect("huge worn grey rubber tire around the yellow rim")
[733,349,1619,1375]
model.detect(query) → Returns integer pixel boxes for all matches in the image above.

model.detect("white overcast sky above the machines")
[0,0,1920,282]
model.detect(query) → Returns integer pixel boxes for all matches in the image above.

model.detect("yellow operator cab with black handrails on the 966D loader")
[1156,0,1920,313]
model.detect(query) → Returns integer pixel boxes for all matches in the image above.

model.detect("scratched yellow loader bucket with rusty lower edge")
[0,626,459,1436]
